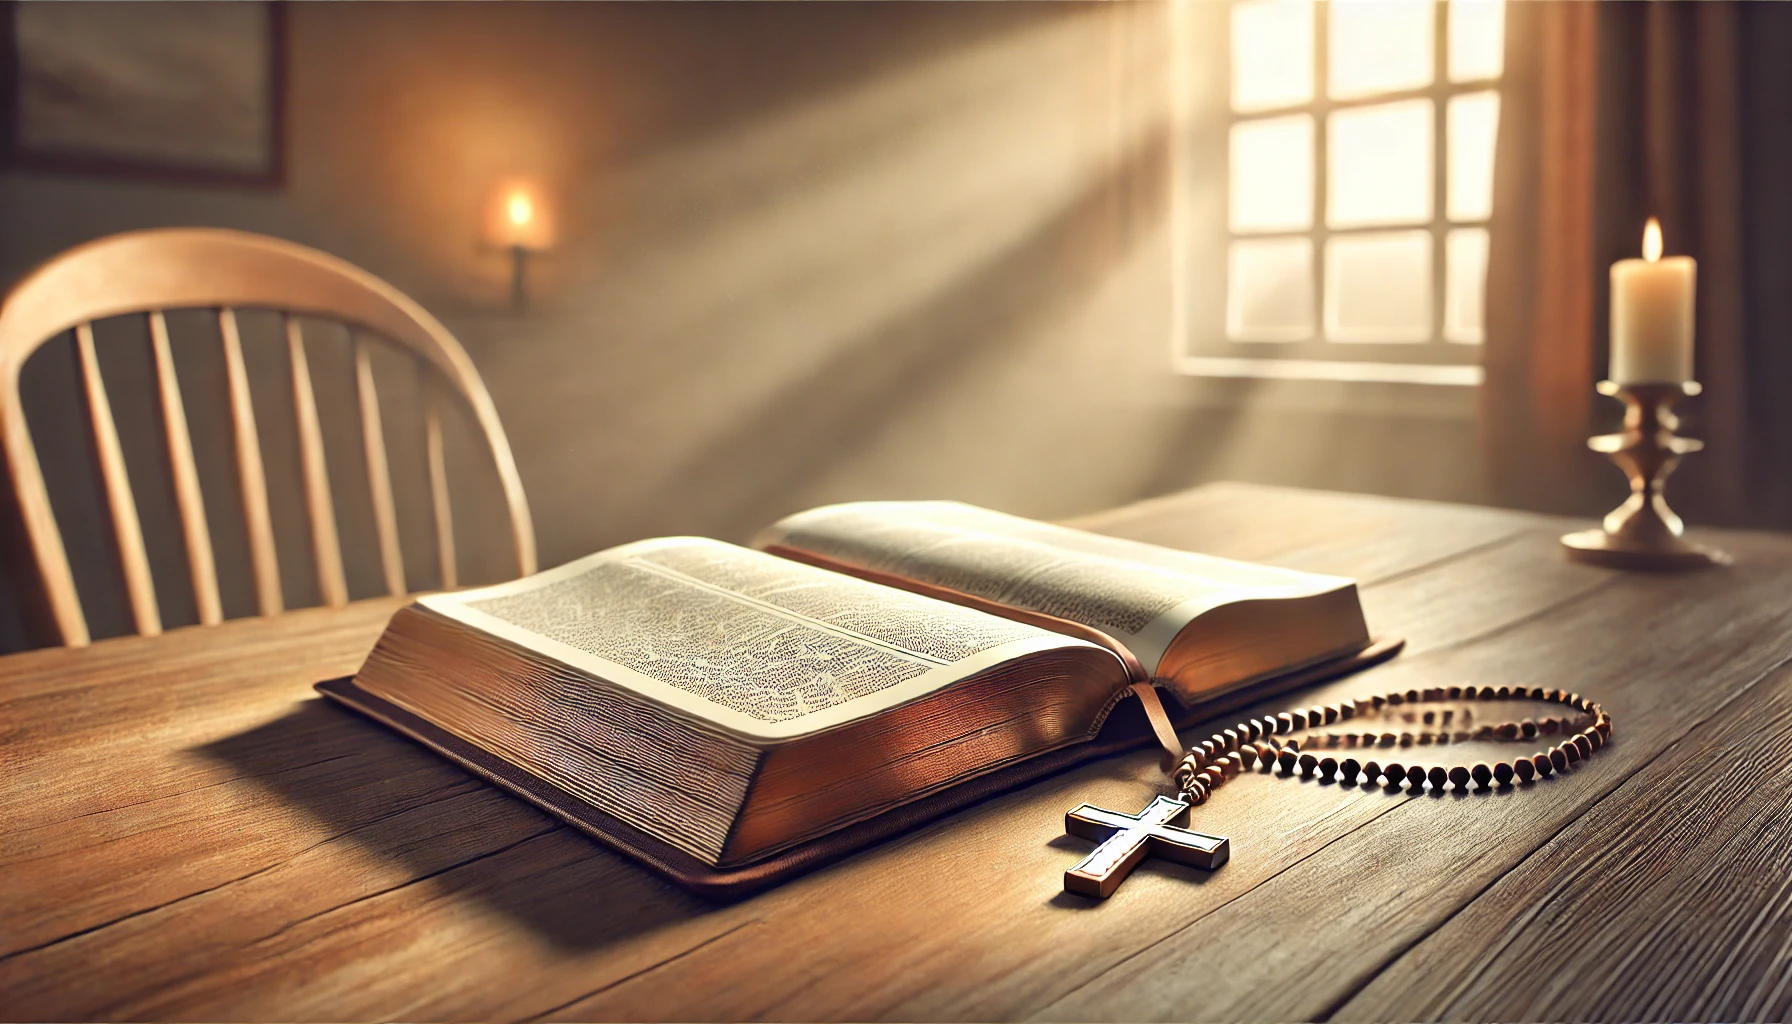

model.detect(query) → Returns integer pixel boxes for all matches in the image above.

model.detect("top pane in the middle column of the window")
[1326,0,1437,99]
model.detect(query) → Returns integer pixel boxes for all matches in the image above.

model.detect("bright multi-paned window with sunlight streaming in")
[1176,0,1505,384]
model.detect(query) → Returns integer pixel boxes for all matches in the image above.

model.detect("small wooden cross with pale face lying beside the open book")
[1064,796,1231,900]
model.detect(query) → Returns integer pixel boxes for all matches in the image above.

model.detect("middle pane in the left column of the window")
[1229,115,1314,231]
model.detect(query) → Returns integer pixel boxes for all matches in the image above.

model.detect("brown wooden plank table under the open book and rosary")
[0,484,1792,1020]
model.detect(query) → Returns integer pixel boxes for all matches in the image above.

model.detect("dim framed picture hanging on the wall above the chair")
[0,0,285,185]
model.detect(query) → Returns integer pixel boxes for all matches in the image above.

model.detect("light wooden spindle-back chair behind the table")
[0,228,536,646]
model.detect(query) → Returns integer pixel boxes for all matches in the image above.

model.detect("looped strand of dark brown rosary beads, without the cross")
[1172,687,1611,805]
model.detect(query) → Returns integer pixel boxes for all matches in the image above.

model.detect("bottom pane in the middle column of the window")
[1326,231,1432,341]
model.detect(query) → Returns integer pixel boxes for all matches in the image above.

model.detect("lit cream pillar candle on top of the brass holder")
[1611,217,1699,384]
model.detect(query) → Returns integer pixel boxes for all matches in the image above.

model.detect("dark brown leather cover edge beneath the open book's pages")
[317,638,1405,900]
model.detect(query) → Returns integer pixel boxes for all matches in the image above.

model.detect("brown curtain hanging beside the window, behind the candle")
[1480,0,1792,525]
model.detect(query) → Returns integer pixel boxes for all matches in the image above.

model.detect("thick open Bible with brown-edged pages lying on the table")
[319,502,1371,891]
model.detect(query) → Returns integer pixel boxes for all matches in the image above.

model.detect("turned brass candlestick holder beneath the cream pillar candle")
[1563,380,1729,570]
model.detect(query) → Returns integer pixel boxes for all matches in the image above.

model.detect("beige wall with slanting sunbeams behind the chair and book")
[0,4,1477,649]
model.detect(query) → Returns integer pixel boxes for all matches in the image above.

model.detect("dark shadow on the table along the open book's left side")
[195,698,715,950]
